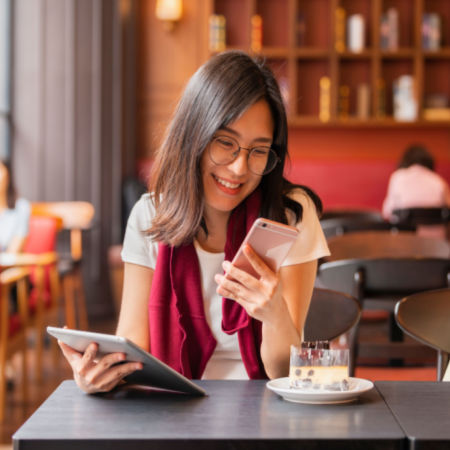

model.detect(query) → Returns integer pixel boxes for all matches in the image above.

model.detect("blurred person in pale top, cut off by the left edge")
[0,161,30,253]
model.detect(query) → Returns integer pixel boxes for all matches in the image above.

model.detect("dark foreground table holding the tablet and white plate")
[13,381,406,450]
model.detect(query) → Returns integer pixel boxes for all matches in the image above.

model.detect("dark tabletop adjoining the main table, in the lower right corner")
[375,381,450,450]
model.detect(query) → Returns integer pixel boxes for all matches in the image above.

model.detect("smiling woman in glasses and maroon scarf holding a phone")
[60,51,328,393]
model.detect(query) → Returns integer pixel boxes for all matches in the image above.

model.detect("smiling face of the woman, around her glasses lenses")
[200,100,274,215]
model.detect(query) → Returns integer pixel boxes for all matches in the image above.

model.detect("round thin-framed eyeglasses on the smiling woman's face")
[208,136,280,175]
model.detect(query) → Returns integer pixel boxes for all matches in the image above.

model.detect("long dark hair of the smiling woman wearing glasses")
[149,51,322,245]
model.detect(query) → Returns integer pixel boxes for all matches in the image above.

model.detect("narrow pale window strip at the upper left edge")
[0,0,11,159]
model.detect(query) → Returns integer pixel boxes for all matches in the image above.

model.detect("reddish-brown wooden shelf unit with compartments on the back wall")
[210,0,450,128]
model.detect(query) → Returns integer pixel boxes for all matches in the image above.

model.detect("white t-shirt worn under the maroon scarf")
[122,189,330,379]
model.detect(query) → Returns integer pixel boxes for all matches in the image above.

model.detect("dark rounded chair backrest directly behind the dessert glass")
[303,288,361,341]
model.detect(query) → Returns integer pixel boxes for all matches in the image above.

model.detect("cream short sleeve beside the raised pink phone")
[282,189,330,266]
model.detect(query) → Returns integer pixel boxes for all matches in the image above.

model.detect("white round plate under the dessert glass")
[266,377,373,405]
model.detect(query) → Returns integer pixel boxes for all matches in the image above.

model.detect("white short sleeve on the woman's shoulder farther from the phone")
[121,194,158,269]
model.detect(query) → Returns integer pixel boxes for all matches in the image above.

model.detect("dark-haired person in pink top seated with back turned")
[383,145,450,239]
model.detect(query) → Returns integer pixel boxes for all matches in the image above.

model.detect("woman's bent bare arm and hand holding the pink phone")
[215,246,317,378]
